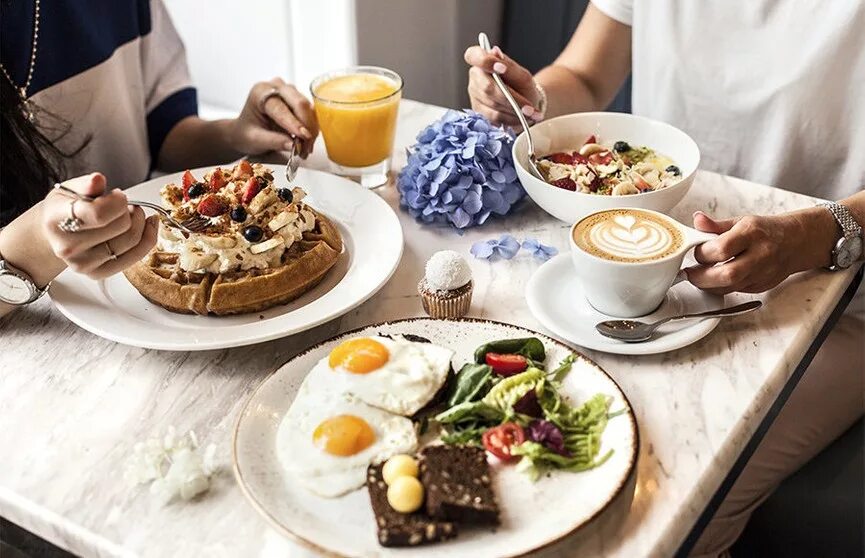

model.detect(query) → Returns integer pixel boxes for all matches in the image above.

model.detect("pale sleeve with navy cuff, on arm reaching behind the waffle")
[141,0,198,163]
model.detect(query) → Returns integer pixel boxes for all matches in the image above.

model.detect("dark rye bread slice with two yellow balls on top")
[366,463,457,546]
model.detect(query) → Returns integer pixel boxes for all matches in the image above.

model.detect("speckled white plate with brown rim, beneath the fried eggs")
[233,318,639,558]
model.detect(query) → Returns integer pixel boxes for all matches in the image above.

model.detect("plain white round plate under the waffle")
[49,167,403,351]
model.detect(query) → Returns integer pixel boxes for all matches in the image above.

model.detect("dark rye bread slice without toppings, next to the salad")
[420,445,499,525]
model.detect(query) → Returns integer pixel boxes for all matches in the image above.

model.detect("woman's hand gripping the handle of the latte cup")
[686,208,837,294]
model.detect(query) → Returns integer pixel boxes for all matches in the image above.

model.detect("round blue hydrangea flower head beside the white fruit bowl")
[397,110,526,229]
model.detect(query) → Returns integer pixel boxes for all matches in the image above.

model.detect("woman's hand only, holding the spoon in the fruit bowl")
[465,46,543,127]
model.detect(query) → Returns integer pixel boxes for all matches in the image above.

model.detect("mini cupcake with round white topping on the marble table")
[418,250,472,318]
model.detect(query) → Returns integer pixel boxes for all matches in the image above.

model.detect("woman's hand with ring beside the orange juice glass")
[230,78,318,159]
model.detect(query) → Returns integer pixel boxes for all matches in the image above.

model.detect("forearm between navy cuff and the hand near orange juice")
[156,116,241,172]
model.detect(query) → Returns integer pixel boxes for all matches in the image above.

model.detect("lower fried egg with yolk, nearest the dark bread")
[276,384,417,498]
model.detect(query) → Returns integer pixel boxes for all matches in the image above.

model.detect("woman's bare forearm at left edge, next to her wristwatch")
[0,202,66,316]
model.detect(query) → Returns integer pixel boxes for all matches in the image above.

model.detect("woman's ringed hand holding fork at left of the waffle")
[41,173,158,279]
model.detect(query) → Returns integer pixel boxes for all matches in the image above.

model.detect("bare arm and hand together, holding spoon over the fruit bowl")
[465,4,631,126]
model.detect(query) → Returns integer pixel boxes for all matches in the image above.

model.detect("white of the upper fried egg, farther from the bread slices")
[309,335,454,416]
